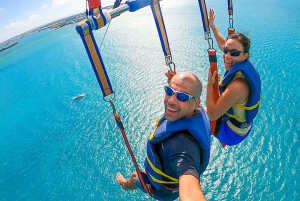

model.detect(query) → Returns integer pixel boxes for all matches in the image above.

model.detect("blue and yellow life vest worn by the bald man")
[145,108,210,191]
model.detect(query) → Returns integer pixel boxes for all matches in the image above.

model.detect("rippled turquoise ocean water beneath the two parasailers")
[0,0,300,201]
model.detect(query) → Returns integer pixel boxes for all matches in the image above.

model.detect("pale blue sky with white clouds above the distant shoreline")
[0,0,115,43]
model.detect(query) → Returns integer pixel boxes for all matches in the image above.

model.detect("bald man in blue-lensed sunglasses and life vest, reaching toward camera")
[116,72,210,201]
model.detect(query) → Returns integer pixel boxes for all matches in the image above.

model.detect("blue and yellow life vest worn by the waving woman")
[219,60,261,128]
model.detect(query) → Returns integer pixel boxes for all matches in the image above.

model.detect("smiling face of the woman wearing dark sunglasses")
[223,39,249,70]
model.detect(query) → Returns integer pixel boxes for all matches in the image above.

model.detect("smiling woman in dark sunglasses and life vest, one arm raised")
[206,9,261,146]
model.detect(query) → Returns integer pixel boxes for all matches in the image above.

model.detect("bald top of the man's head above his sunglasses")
[170,72,202,98]
